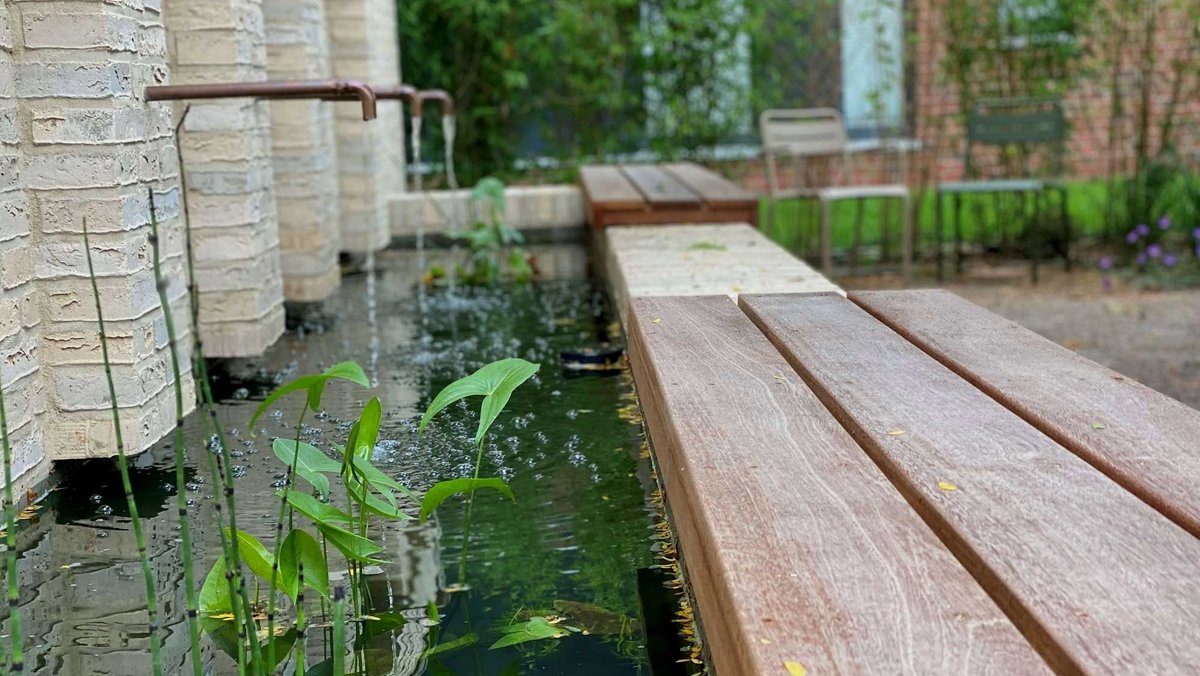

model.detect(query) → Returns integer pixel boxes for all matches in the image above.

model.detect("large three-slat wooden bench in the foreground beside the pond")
[629,292,1200,674]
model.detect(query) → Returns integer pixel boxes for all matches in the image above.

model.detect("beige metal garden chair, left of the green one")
[758,108,912,280]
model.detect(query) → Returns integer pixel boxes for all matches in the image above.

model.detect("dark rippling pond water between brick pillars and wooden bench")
[0,246,655,675]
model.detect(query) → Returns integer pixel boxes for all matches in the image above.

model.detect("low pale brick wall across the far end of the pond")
[391,185,587,237]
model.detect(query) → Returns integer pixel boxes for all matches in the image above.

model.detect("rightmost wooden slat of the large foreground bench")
[851,291,1200,537]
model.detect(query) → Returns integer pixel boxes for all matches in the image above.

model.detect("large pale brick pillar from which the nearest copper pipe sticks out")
[0,0,193,460]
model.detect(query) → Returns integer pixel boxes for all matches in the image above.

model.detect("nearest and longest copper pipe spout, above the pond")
[145,79,376,120]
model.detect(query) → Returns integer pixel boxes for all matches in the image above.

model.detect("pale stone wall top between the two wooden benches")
[593,223,846,322]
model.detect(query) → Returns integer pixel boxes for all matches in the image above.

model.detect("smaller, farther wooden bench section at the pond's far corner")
[580,162,758,229]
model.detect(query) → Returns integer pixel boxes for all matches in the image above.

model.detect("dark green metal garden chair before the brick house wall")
[935,97,1070,282]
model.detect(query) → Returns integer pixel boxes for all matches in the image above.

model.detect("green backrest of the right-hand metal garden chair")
[965,97,1067,177]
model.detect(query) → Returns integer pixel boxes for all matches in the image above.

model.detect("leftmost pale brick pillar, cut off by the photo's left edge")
[0,0,49,486]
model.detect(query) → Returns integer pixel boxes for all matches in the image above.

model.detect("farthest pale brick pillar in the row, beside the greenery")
[324,0,404,252]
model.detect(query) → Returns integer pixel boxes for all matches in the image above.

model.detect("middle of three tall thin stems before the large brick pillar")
[146,189,203,676]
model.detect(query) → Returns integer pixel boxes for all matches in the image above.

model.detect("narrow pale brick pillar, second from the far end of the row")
[263,0,342,301]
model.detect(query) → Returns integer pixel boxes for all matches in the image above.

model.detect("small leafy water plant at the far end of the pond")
[446,177,534,286]
